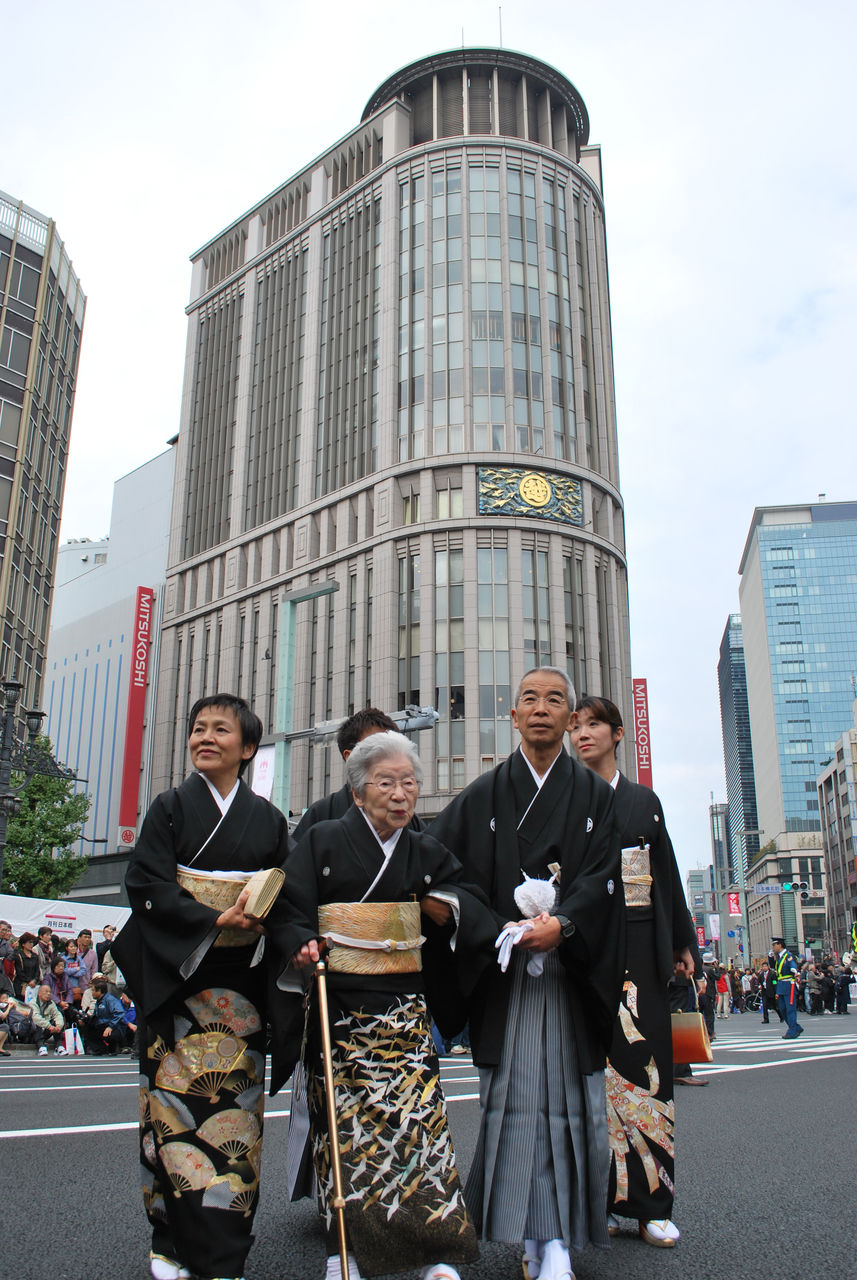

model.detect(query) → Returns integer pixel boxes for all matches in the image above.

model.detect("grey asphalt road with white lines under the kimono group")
[0,1010,857,1280]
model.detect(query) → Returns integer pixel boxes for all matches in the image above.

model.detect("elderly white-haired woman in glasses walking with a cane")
[279,732,498,1280]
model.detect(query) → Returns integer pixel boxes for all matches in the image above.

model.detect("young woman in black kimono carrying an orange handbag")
[570,695,698,1248]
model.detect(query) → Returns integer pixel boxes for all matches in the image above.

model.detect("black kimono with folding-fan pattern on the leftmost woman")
[111,773,289,1277]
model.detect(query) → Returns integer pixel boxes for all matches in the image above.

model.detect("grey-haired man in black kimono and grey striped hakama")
[430,667,624,1280]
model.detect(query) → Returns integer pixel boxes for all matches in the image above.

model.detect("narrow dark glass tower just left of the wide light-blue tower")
[718,613,759,883]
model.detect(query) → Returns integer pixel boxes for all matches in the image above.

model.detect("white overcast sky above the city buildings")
[0,0,857,869]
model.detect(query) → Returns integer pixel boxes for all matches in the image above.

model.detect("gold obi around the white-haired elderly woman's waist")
[318,902,426,974]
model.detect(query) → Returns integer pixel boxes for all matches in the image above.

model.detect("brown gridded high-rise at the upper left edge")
[0,192,86,707]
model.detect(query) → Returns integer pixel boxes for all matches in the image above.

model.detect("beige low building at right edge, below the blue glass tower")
[817,701,857,954]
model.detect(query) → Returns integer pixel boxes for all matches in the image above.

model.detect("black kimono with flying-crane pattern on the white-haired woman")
[278,805,496,1276]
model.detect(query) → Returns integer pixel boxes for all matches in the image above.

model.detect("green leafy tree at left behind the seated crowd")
[3,737,90,897]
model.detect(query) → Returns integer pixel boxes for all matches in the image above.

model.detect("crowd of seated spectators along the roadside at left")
[0,920,138,1057]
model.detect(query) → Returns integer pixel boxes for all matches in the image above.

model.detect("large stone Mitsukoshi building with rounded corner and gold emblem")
[155,49,633,812]
